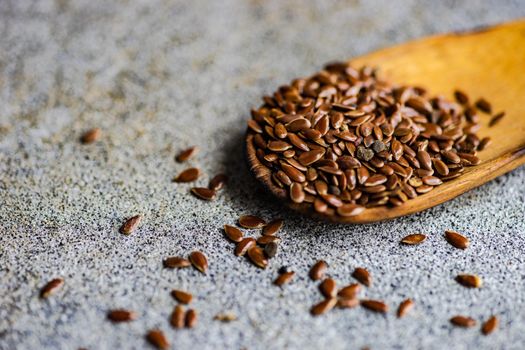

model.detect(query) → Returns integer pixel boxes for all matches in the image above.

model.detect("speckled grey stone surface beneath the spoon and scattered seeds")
[0,0,525,350]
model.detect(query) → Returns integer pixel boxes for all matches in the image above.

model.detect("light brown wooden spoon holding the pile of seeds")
[246,20,525,223]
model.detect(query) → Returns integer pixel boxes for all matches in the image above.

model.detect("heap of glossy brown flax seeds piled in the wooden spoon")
[248,63,496,216]
